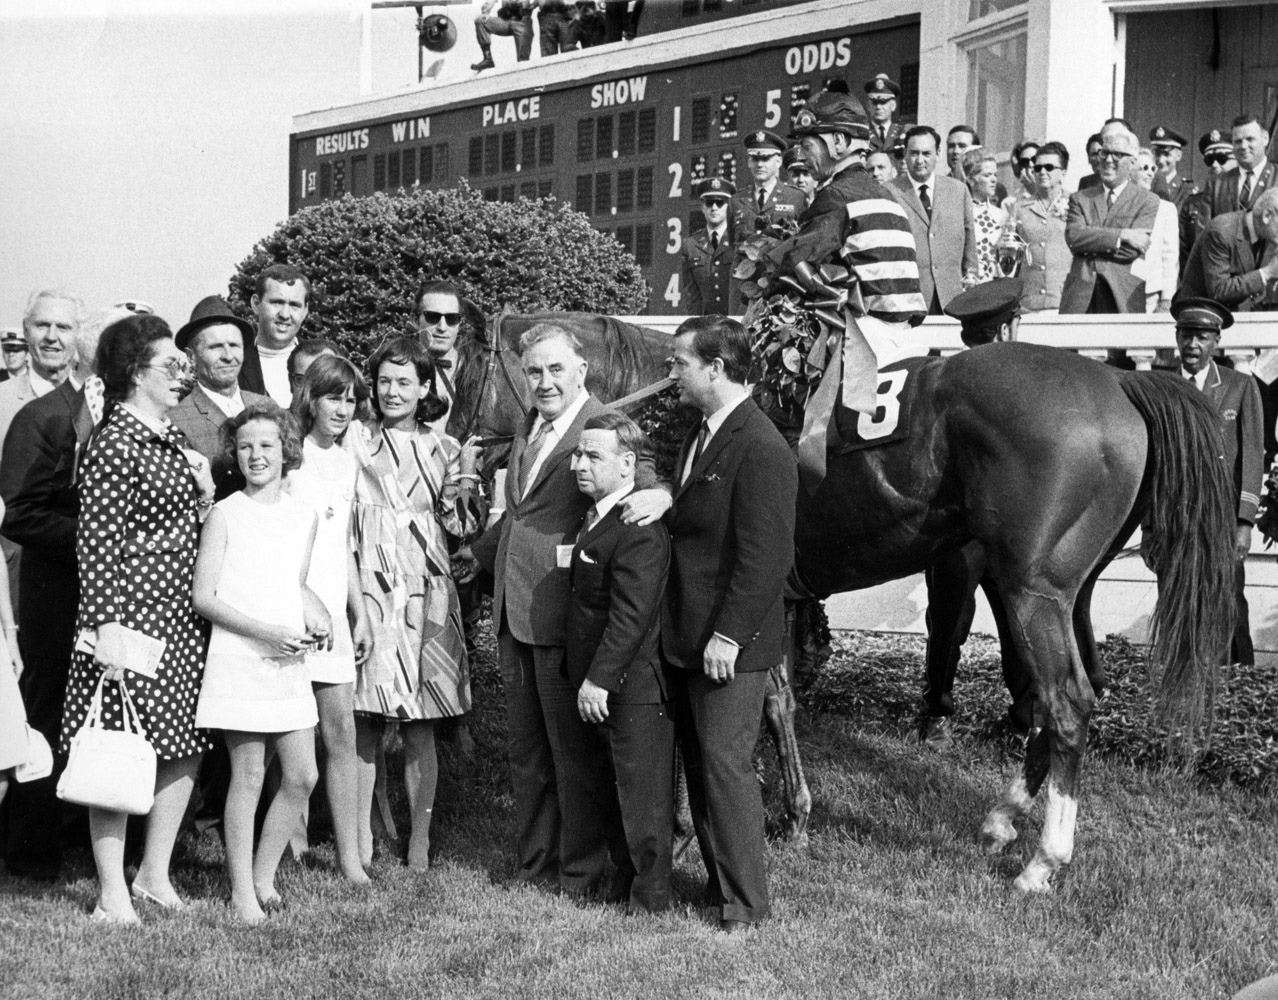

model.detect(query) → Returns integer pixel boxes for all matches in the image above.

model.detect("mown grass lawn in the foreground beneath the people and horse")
[0,636,1278,1000]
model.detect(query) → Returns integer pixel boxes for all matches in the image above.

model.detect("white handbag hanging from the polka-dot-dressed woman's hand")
[58,674,156,816]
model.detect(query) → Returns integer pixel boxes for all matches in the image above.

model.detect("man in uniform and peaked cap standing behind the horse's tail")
[1172,298,1264,666]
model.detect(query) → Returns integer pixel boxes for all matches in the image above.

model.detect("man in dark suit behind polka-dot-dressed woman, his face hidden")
[0,308,120,879]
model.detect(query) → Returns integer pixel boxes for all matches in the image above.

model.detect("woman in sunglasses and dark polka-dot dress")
[61,315,213,923]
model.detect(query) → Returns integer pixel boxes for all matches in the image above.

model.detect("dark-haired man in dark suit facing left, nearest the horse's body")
[661,316,799,931]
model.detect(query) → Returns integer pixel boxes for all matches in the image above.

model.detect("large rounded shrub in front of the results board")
[222,182,648,363]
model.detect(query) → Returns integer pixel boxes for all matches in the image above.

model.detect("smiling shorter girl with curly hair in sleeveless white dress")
[192,402,332,923]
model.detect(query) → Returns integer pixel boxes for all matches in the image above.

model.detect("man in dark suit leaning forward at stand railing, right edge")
[1176,188,1278,311]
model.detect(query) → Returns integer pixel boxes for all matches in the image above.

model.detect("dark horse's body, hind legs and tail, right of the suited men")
[795,343,1235,891]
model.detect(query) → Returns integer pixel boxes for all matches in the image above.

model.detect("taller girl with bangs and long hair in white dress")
[285,354,373,882]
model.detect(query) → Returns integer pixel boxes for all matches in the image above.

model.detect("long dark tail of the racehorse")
[1121,372,1237,734]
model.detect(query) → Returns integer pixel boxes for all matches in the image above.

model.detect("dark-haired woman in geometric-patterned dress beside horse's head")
[351,336,479,868]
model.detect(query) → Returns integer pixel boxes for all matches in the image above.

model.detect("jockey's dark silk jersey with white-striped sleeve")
[785,164,928,322]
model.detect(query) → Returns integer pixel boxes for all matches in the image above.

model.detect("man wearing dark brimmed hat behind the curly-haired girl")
[169,295,267,500]
